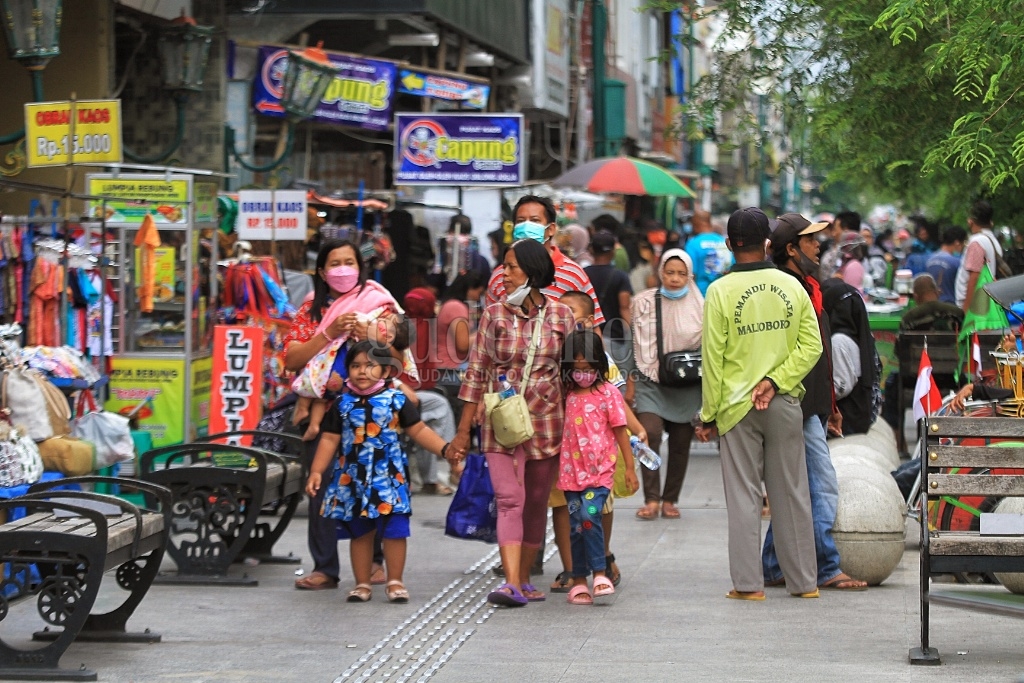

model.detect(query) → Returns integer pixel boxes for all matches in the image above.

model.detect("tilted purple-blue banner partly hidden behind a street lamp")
[253,45,397,130]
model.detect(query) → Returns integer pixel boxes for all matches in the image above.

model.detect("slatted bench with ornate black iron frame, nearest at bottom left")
[0,476,171,681]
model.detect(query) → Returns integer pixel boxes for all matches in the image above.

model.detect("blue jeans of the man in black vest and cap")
[761,416,842,586]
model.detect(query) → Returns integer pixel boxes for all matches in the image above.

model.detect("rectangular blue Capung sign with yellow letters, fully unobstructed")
[394,114,526,185]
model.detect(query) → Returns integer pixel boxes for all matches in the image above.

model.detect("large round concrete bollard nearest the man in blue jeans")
[833,466,906,586]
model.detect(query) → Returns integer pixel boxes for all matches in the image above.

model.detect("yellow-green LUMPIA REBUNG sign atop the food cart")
[87,176,188,224]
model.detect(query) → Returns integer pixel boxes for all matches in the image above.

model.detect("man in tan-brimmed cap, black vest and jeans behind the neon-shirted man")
[761,213,867,591]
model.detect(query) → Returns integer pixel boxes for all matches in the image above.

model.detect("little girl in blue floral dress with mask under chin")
[306,341,454,602]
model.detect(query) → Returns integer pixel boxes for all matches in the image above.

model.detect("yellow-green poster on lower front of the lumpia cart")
[104,355,185,446]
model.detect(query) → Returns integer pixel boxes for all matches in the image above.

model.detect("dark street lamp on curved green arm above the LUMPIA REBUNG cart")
[124,10,214,164]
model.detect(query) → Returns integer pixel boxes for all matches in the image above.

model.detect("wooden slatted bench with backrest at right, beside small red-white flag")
[910,418,1024,665]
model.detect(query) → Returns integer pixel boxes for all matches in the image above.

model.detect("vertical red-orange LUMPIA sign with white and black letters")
[210,325,263,445]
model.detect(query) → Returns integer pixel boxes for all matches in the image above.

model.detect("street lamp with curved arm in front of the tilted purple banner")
[224,42,338,179]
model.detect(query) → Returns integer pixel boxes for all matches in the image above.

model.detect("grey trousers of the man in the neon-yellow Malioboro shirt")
[721,395,817,593]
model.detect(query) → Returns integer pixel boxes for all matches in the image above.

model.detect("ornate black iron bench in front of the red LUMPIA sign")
[139,435,305,586]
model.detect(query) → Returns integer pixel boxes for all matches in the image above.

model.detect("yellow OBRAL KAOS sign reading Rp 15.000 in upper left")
[25,99,122,168]
